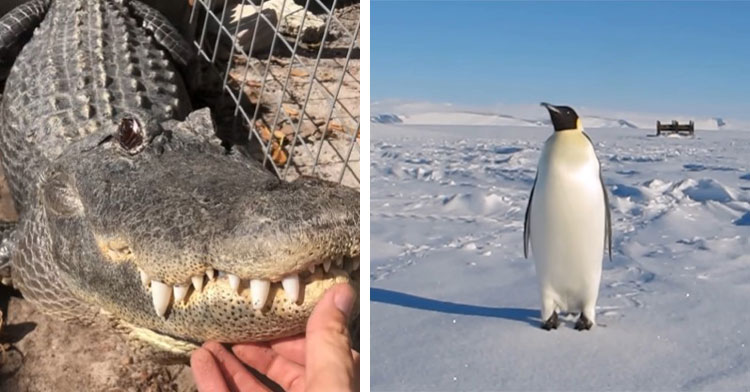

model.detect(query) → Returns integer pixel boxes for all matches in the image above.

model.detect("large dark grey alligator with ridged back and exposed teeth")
[0,0,359,356]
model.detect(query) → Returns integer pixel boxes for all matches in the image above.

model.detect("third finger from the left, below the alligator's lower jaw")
[232,343,305,391]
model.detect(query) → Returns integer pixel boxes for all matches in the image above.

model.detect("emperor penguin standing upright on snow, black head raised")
[523,103,612,331]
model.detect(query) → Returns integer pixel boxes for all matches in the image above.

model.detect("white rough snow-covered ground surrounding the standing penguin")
[370,123,750,391]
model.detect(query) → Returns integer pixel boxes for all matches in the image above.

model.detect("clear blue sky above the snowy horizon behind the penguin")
[370,0,750,119]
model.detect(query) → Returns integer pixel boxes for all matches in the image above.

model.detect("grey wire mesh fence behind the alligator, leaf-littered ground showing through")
[190,0,360,187]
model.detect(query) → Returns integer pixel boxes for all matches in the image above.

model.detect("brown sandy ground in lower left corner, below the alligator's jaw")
[0,288,195,392]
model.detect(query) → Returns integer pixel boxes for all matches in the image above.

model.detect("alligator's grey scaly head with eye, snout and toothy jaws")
[37,110,359,350]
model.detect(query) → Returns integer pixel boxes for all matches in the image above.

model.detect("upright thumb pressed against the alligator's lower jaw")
[305,283,355,391]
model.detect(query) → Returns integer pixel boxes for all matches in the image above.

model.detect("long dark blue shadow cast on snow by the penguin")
[370,288,539,326]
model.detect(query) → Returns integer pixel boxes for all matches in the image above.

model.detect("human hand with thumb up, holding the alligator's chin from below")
[190,283,359,392]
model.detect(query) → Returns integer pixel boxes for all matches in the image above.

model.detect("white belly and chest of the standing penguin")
[529,131,605,312]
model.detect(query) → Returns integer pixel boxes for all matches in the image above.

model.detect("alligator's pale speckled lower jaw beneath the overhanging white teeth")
[108,256,359,344]
